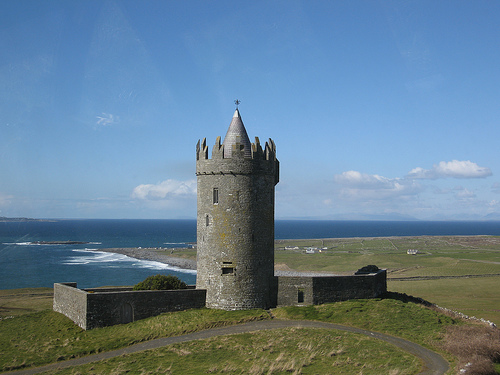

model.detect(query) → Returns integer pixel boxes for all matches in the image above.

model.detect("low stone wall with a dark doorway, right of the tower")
[278,270,387,306]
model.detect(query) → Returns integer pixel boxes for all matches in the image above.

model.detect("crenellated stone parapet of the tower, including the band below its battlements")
[196,137,279,184]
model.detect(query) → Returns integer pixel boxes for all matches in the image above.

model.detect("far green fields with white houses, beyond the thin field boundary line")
[275,236,500,277]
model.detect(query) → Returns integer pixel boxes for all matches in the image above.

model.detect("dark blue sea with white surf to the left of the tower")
[0,220,196,289]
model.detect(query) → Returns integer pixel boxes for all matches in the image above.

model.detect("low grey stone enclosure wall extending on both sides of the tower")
[54,270,387,329]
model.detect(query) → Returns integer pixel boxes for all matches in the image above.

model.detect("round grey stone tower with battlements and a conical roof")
[196,109,279,310]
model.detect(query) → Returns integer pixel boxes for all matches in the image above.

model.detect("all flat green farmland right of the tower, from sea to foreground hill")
[275,236,500,325]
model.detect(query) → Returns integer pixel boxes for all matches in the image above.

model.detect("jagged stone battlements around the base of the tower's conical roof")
[196,136,276,161]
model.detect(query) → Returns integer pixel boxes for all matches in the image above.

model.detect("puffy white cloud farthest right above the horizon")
[407,160,492,180]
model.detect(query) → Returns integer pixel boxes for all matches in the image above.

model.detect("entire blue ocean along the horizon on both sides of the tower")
[0,219,500,289]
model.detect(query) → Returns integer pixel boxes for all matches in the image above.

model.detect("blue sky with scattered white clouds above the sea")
[0,0,500,219]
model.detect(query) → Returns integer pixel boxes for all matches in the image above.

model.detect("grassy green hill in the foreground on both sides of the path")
[0,296,450,374]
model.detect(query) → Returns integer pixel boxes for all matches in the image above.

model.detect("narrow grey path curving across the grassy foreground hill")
[3,319,448,375]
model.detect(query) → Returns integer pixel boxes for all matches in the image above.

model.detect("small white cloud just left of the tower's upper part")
[132,179,196,200]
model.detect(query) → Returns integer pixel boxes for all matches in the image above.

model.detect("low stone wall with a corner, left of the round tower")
[54,283,206,330]
